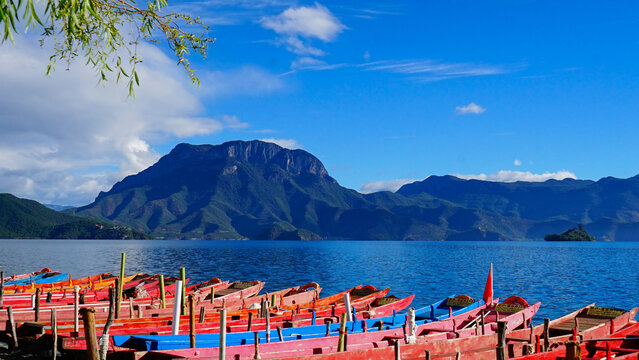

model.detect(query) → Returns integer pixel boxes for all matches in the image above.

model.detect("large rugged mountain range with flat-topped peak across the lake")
[67,141,639,241]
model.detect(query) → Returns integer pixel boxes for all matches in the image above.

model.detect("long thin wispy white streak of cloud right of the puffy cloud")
[359,59,520,81]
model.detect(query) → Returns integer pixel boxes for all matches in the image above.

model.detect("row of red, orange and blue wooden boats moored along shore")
[0,268,639,360]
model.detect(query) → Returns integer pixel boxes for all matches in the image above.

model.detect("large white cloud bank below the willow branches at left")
[0,37,255,205]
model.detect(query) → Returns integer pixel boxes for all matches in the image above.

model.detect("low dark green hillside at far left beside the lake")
[0,194,149,239]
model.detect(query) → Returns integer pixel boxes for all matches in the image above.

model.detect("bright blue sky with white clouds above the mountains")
[0,0,639,205]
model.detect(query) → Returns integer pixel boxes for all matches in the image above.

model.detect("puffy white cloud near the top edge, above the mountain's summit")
[259,3,346,63]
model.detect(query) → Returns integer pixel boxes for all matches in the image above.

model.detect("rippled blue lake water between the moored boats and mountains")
[0,240,639,322]
